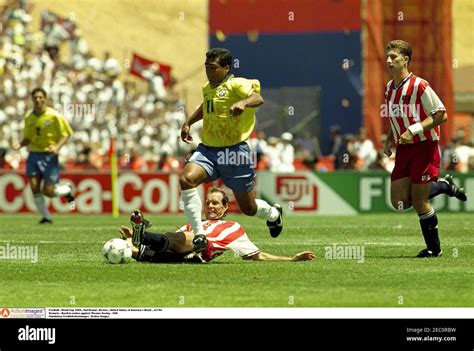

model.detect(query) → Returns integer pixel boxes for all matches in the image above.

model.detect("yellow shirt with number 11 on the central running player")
[201,75,260,147]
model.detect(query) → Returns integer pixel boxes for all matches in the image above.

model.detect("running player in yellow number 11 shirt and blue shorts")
[180,48,283,252]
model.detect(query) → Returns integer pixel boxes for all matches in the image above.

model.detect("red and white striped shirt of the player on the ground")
[179,219,260,261]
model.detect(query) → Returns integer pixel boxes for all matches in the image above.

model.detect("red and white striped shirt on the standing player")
[382,73,446,143]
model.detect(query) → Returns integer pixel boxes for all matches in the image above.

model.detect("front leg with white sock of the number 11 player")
[179,162,208,235]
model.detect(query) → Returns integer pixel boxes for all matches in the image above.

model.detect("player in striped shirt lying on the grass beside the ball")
[120,188,315,263]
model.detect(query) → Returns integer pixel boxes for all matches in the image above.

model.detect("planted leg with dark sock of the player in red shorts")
[411,182,442,257]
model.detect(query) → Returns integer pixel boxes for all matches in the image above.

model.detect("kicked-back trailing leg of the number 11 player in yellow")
[234,189,283,238]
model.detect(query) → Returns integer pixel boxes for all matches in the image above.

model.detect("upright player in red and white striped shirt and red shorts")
[382,40,467,257]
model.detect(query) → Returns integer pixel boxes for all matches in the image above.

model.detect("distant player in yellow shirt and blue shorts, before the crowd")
[13,88,74,224]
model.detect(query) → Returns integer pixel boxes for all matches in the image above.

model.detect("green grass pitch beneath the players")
[0,213,474,308]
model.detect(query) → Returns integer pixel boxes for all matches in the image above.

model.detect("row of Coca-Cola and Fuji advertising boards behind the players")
[0,171,474,215]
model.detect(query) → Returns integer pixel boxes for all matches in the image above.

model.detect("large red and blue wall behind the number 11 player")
[209,0,362,153]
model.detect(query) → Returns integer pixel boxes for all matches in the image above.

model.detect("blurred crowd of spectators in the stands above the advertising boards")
[0,0,474,172]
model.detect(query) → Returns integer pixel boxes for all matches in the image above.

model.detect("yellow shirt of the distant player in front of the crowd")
[23,107,72,152]
